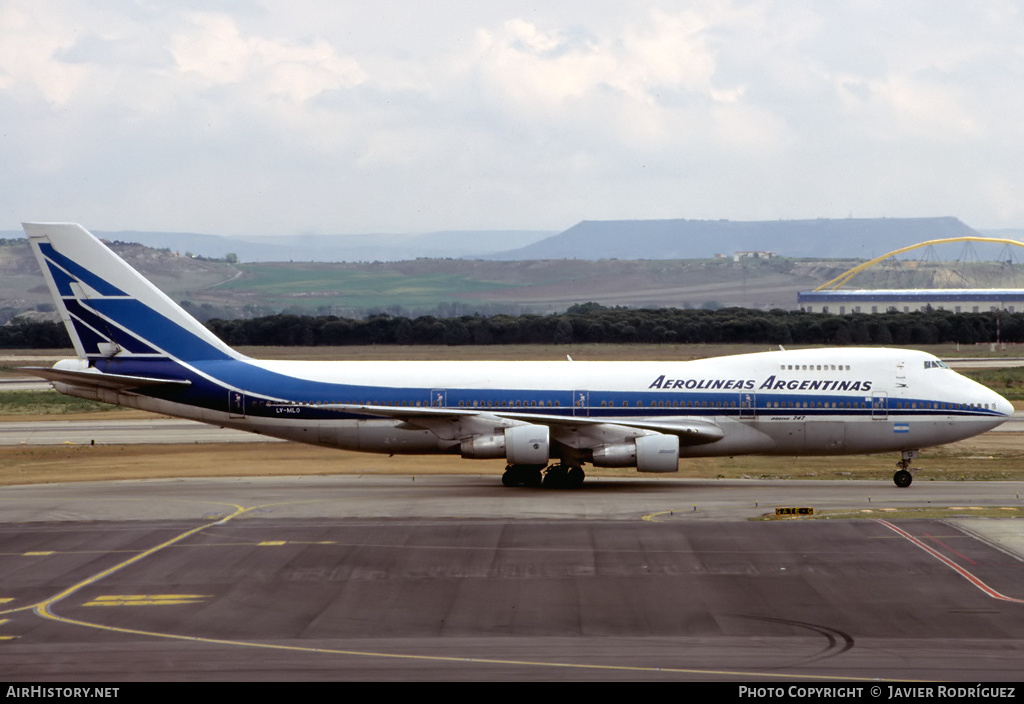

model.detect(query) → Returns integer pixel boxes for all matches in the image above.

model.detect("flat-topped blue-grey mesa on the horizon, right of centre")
[490,217,978,261]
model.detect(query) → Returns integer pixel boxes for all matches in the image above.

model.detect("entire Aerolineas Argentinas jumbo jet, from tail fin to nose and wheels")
[25,223,1013,487]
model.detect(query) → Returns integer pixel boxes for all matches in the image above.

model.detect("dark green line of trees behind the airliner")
[0,303,1024,349]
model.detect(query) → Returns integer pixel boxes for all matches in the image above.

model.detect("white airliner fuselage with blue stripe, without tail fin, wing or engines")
[61,349,1013,456]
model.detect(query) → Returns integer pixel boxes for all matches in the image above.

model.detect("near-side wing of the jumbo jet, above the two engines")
[321,403,725,445]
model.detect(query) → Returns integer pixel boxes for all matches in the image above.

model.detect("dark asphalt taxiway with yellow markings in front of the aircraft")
[0,475,1024,683]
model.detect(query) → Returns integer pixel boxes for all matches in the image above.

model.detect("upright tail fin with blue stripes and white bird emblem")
[23,223,242,362]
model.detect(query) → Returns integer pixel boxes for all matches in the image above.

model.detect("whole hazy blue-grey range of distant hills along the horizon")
[0,217,999,262]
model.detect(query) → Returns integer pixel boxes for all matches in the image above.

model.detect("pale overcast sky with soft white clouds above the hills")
[0,0,1024,234]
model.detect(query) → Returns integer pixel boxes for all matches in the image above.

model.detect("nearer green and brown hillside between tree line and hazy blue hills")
[0,237,851,323]
